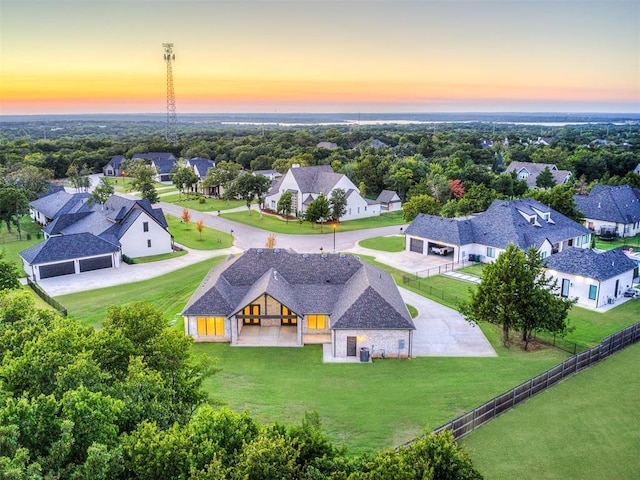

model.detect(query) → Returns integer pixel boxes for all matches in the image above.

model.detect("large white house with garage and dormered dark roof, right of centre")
[405,198,591,263]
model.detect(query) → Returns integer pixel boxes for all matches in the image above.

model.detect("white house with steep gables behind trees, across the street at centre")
[264,165,380,220]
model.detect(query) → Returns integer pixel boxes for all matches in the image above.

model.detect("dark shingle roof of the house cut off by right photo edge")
[574,185,640,224]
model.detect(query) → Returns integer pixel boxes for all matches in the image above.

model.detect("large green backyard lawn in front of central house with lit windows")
[193,343,565,453]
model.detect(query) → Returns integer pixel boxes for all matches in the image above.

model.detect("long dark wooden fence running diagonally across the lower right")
[401,322,640,446]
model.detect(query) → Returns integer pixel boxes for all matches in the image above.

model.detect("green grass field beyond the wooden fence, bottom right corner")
[462,344,640,480]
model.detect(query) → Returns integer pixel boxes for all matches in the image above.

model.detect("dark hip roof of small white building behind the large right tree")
[546,248,636,281]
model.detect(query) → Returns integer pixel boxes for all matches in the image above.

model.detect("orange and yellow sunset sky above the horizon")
[0,0,640,115]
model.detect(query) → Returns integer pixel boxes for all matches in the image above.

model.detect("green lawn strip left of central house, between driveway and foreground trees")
[56,255,226,327]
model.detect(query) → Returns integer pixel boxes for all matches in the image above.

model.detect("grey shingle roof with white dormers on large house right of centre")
[406,198,589,250]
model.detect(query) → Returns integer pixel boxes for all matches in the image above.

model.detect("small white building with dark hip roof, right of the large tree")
[546,248,637,308]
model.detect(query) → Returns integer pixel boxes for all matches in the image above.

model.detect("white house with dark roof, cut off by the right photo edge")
[573,185,640,237]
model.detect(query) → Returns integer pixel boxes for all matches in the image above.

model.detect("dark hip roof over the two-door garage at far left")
[19,233,120,265]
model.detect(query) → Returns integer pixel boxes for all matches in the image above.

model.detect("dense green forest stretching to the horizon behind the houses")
[0,116,640,220]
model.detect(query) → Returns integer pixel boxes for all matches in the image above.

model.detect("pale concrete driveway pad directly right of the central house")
[400,288,497,357]
